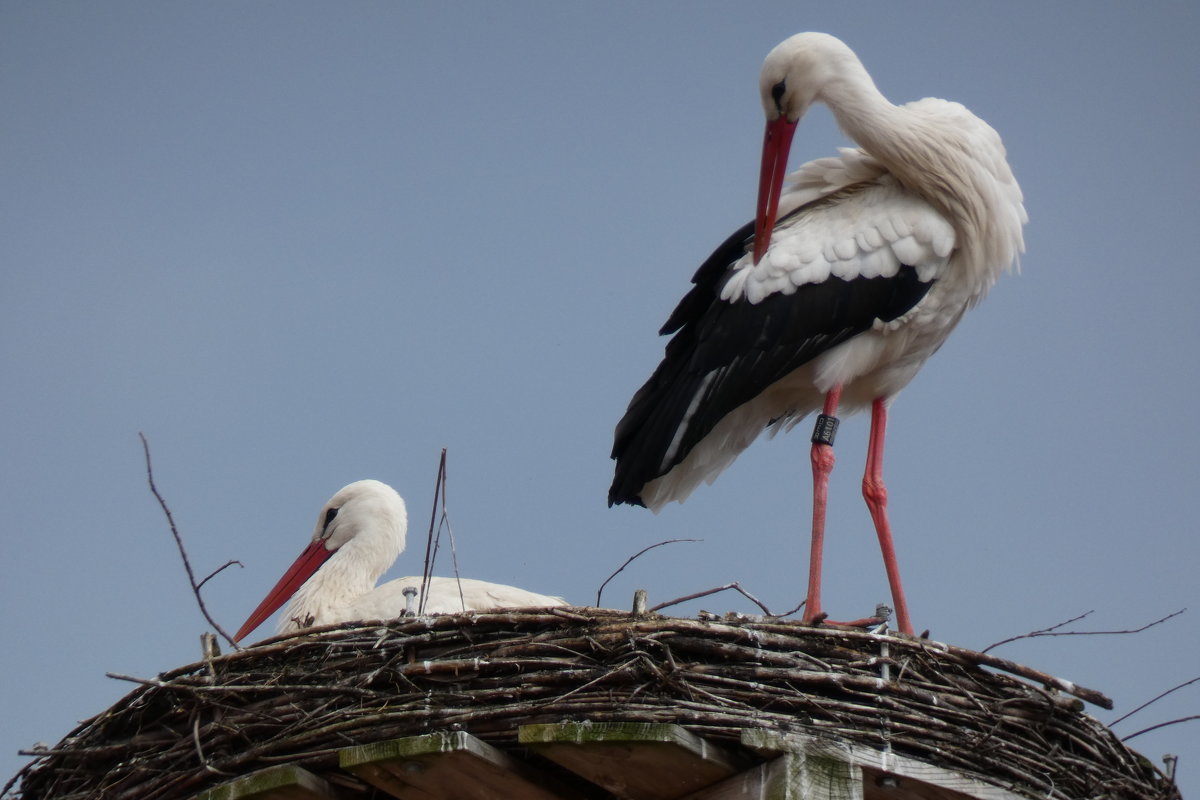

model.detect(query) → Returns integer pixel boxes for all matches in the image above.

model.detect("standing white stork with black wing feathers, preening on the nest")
[608,34,1027,633]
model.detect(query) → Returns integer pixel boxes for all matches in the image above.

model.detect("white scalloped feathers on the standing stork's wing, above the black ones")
[721,186,954,303]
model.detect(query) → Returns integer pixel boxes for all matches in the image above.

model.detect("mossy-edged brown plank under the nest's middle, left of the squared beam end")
[517,722,738,800]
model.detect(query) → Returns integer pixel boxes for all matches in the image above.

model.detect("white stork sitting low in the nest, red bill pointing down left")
[234,481,566,642]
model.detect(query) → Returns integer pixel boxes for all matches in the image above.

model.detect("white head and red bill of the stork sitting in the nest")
[233,481,408,642]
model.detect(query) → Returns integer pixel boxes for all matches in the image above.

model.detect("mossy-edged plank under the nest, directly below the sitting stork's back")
[338,730,572,800]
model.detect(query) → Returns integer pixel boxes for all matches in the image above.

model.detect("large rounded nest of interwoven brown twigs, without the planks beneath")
[6,608,1178,800]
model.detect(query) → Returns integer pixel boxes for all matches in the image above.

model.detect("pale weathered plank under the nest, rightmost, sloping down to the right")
[742,728,1027,800]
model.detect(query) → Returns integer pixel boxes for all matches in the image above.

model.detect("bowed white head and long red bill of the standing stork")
[754,34,865,264]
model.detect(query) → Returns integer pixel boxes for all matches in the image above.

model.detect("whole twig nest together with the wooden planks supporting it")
[2,608,1178,800]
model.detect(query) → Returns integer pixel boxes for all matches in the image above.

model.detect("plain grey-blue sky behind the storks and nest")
[0,1,1200,795]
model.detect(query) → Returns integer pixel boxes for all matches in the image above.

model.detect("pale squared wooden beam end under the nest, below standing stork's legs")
[685,753,863,800]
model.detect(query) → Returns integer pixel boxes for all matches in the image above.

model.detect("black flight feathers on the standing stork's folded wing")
[608,222,932,505]
